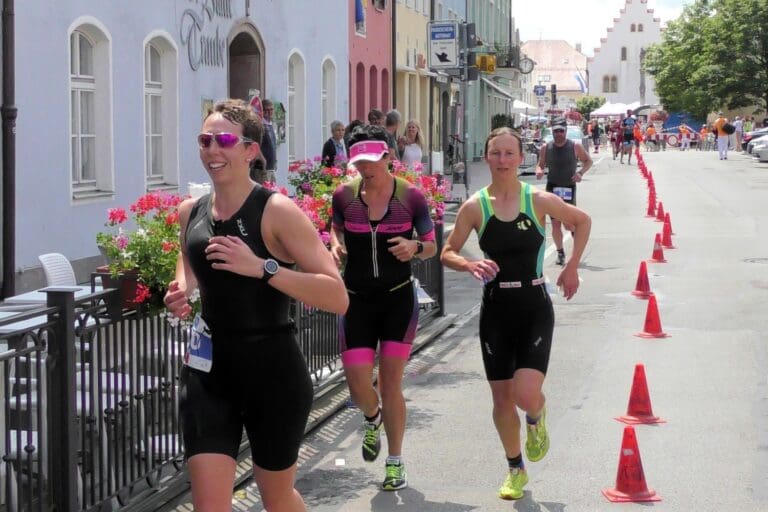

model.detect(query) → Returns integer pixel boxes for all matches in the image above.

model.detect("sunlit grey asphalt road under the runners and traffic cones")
[233,151,768,512]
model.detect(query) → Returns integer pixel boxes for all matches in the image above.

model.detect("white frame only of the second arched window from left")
[143,32,179,191]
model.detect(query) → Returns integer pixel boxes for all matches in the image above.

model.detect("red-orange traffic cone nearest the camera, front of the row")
[603,427,661,503]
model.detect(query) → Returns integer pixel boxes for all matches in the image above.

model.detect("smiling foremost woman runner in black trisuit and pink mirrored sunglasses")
[165,100,349,512]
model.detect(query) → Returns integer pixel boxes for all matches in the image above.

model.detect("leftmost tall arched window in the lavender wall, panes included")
[69,23,114,199]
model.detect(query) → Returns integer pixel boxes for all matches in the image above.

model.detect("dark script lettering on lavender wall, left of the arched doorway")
[179,0,232,71]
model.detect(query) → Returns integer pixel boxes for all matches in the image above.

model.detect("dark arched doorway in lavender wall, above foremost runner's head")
[229,31,265,101]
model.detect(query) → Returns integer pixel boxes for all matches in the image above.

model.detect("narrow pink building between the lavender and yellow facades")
[349,0,394,122]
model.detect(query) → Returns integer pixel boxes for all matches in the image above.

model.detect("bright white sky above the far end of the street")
[512,0,692,57]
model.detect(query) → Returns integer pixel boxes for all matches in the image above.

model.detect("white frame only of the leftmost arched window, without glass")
[67,21,115,202]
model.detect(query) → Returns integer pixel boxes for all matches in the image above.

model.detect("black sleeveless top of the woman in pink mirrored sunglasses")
[185,185,291,335]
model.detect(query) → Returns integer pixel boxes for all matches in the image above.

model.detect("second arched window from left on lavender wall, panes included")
[144,37,179,190]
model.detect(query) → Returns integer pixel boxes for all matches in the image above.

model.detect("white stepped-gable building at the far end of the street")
[587,0,663,105]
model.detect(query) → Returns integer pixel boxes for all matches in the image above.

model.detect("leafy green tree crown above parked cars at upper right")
[645,0,768,118]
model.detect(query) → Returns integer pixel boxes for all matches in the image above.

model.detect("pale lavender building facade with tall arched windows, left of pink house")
[16,0,349,289]
